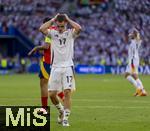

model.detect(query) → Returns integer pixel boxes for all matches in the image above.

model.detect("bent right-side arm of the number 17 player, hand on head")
[65,14,82,35]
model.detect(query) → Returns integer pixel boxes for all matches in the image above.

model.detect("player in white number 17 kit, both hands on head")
[39,14,81,126]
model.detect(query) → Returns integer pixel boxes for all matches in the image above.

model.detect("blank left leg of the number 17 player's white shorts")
[48,67,62,91]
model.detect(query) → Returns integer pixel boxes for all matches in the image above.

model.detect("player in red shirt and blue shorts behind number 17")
[28,18,64,114]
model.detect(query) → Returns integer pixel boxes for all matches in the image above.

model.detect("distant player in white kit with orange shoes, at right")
[125,28,147,96]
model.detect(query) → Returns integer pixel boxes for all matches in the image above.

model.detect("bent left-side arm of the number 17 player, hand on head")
[39,18,54,35]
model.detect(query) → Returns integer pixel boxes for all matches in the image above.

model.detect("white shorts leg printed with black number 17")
[63,67,75,90]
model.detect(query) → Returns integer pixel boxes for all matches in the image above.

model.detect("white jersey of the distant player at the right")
[128,39,141,65]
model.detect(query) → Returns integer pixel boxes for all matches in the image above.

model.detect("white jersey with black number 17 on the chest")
[48,29,75,67]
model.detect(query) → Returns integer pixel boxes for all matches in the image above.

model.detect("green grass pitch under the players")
[0,74,150,131]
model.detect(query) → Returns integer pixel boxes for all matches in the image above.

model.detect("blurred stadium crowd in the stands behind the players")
[0,0,150,65]
